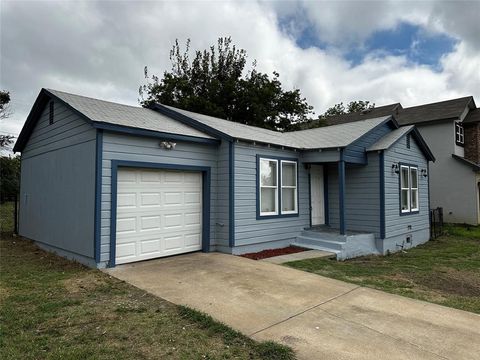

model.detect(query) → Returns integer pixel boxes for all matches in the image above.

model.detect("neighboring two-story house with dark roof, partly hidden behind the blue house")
[327,96,480,225]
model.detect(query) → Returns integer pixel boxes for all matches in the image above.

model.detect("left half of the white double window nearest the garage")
[260,159,278,216]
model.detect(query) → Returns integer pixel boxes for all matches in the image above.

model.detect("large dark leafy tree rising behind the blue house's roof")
[139,37,313,131]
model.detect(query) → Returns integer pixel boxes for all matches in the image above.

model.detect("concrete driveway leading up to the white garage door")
[106,253,480,360]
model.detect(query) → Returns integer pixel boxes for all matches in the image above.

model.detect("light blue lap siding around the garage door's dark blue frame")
[100,132,222,262]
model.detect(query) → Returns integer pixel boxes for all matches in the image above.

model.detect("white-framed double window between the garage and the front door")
[257,158,298,216]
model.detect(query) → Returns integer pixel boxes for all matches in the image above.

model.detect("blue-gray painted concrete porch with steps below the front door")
[293,225,379,260]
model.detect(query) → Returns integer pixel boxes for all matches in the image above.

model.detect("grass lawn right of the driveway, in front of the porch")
[286,225,480,313]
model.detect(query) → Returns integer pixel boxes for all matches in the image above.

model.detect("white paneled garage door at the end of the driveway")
[115,168,202,264]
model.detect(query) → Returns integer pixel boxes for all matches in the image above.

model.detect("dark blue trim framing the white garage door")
[108,160,211,267]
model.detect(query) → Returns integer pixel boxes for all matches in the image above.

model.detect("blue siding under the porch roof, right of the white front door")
[327,153,380,237]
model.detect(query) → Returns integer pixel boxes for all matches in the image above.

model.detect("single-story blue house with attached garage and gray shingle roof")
[14,89,434,267]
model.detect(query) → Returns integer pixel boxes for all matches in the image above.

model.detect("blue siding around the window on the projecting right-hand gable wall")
[385,136,430,240]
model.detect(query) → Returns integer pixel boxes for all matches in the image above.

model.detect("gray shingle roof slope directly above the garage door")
[47,89,213,139]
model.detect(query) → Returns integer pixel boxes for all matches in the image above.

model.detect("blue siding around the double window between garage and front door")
[235,143,310,246]
